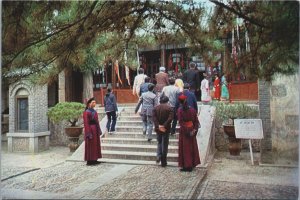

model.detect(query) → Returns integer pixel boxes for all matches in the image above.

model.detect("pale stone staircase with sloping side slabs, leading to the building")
[67,103,215,168]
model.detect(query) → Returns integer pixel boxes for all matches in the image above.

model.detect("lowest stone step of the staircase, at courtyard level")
[98,158,178,167]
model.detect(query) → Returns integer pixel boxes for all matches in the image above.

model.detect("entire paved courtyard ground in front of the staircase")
[1,147,299,199]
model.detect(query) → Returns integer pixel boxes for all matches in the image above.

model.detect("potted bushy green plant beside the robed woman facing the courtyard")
[47,102,85,152]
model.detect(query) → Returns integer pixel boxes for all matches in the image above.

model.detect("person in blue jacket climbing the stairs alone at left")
[104,88,118,134]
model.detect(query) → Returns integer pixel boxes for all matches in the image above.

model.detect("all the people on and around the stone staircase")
[83,63,228,171]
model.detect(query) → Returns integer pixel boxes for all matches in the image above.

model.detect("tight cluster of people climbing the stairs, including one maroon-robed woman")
[133,66,200,171]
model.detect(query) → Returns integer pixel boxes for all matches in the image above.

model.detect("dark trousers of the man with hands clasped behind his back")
[156,133,170,166]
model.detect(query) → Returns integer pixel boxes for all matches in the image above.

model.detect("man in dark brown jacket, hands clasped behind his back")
[153,95,174,167]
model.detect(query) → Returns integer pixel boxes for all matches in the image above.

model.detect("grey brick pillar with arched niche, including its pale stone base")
[7,79,50,153]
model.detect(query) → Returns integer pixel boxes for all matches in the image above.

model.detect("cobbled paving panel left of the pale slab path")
[2,162,112,193]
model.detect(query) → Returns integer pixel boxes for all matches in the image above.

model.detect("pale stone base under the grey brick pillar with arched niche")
[7,131,50,153]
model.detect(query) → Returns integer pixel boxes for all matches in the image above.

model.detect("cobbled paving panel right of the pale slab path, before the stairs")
[86,166,206,199]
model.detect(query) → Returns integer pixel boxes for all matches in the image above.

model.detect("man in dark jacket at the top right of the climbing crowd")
[182,62,200,96]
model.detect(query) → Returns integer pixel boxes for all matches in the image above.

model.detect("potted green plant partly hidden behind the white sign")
[214,102,258,156]
